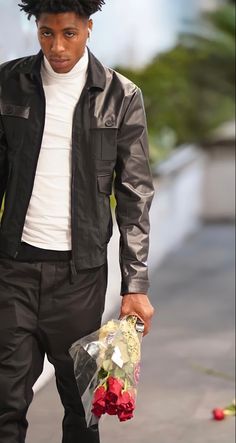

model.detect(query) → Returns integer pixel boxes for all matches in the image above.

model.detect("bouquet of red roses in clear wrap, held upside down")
[69,316,144,426]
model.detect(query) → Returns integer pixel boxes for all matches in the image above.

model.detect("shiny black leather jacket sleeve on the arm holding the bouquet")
[115,88,154,294]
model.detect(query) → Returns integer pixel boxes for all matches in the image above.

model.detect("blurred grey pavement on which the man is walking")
[27,225,235,443]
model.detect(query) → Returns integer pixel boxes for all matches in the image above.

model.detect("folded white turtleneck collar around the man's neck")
[42,48,89,80]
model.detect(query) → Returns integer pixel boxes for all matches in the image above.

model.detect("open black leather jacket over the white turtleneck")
[0,48,153,293]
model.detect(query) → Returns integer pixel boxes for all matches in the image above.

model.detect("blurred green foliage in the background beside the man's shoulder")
[115,5,235,161]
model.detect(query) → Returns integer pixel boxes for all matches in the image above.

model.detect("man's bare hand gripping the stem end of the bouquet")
[120,293,154,335]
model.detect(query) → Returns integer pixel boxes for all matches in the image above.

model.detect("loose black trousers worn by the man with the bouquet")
[0,248,107,443]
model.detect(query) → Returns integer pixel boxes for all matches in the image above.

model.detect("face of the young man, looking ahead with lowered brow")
[37,12,92,74]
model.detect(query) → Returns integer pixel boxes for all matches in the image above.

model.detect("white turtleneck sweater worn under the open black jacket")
[22,49,88,251]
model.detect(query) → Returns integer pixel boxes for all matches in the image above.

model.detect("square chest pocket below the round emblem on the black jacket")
[90,127,118,161]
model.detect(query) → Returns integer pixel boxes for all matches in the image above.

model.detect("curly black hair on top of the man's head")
[18,0,105,19]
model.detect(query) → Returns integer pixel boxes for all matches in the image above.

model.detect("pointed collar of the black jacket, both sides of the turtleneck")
[19,49,106,90]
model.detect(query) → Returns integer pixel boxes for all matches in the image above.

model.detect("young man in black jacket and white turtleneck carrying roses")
[0,0,153,443]
